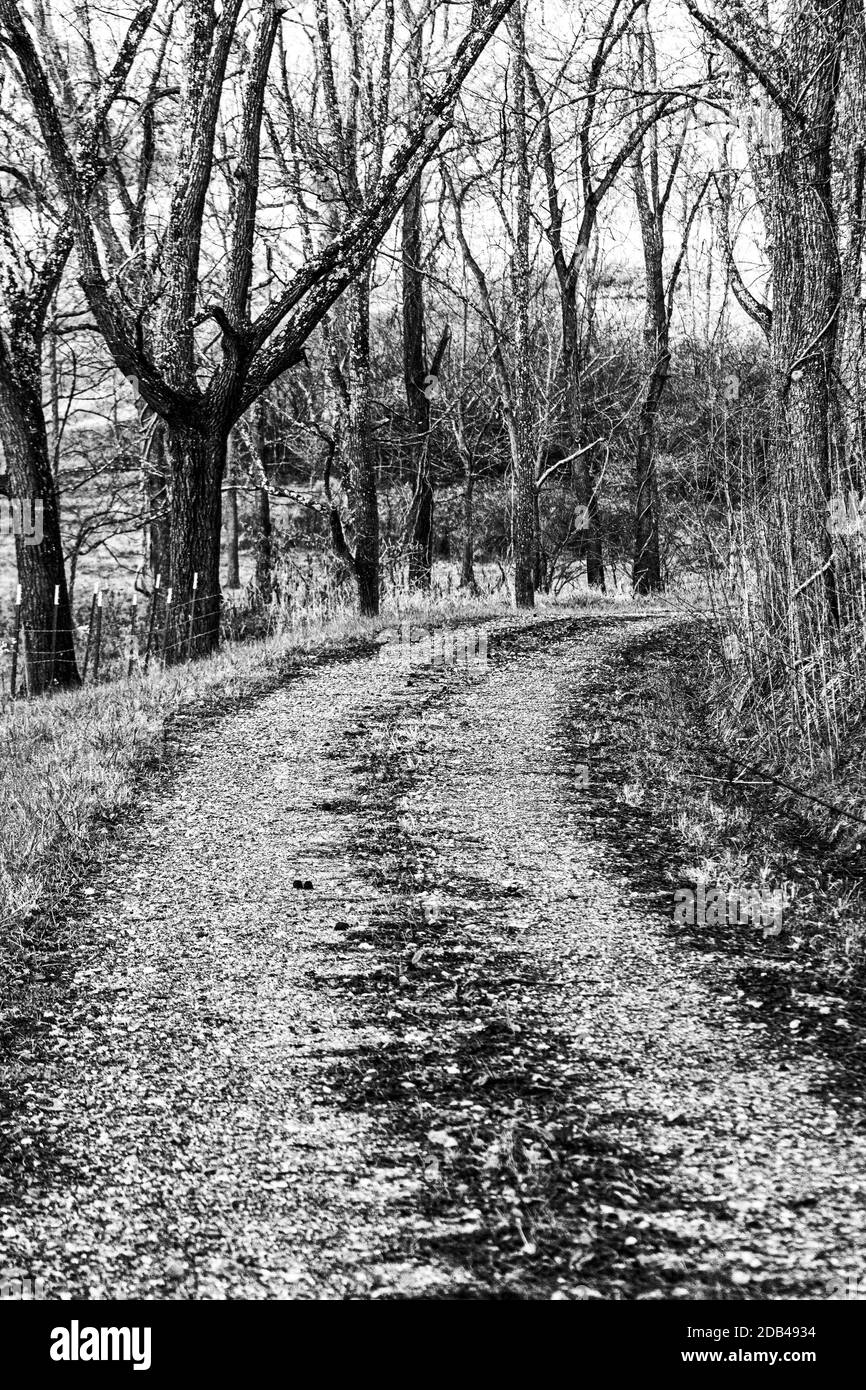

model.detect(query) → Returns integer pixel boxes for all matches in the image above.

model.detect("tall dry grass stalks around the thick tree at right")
[695,417,866,849]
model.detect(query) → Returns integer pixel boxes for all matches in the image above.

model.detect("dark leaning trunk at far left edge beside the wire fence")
[0,361,79,694]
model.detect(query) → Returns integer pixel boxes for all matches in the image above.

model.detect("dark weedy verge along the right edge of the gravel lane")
[608,619,866,992]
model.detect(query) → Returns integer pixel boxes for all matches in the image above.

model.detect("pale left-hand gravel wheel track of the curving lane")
[0,644,467,1298]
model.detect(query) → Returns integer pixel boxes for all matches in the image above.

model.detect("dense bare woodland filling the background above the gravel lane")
[0,0,866,756]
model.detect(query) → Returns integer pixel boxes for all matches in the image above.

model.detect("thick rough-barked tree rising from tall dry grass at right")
[685,0,862,616]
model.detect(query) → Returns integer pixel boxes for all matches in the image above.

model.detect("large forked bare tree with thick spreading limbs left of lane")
[0,0,513,652]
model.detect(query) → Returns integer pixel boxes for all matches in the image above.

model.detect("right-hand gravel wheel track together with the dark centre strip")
[322,619,866,1298]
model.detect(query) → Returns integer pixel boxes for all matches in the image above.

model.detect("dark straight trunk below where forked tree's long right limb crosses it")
[403,178,434,589]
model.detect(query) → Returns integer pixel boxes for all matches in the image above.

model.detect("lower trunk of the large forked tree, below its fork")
[165,421,228,664]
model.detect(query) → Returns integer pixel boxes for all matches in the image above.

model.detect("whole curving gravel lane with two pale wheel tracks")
[0,619,866,1298]
